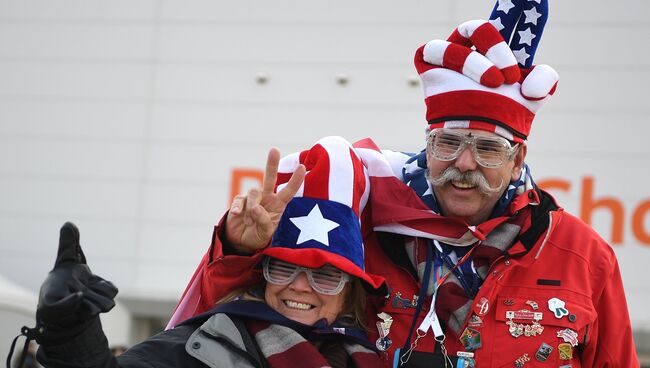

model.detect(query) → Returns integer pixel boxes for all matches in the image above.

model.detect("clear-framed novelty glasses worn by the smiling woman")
[263,258,350,295]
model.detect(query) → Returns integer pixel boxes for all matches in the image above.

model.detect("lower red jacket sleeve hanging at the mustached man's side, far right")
[582,245,639,367]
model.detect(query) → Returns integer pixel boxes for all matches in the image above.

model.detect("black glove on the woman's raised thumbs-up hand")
[36,222,117,335]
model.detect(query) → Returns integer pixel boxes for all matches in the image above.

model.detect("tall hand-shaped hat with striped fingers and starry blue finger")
[415,0,558,143]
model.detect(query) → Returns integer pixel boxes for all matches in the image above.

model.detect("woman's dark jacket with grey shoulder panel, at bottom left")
[38,313,266,368]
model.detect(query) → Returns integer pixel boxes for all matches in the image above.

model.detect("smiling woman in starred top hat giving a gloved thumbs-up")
[26,139,387,368]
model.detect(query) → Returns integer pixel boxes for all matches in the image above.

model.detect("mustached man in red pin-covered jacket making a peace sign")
[170,21,639,367]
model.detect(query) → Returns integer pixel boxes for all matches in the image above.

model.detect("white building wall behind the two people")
[0,0,650,350]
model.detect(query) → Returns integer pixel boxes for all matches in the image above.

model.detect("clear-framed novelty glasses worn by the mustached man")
[427,129,519,168]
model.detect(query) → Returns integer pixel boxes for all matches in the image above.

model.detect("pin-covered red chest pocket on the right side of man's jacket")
[492,289,595,368]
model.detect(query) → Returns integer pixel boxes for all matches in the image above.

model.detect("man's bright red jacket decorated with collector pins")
[190,194,639,368]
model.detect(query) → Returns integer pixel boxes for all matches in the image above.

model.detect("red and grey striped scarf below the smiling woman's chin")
[246,319,383,368]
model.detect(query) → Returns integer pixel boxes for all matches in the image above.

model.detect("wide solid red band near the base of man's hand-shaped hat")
[424,90,535,137]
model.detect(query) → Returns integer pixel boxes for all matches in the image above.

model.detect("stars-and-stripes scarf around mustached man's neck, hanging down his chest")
[355,140,539,335]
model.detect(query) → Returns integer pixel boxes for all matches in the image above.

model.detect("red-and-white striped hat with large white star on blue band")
[262,137,387,295]
